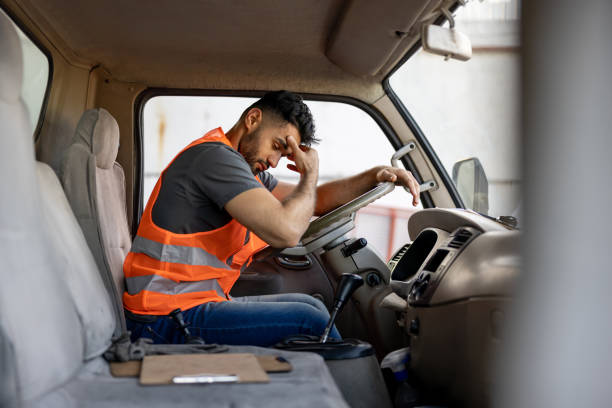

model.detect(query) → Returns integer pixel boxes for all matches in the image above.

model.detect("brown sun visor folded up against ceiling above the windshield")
[326,0,441,76]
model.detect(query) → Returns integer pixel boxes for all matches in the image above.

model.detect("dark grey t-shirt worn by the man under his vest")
[152,142,278,234]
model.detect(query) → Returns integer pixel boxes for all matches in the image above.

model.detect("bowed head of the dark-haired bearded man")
[238,91,318,174]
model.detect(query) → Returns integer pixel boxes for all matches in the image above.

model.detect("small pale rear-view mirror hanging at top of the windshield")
[421,24,472,61]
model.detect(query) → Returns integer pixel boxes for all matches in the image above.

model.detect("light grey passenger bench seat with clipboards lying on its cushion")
[0,12,347,408]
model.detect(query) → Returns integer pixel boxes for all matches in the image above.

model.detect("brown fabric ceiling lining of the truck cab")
[0,0,431,104]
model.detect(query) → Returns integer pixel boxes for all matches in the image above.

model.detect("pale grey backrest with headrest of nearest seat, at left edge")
[0,13,103,406]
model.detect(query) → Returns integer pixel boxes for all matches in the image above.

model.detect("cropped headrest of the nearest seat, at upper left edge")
[0,10,23,103]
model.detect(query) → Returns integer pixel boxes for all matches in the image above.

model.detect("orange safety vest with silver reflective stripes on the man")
[123,128,267,315]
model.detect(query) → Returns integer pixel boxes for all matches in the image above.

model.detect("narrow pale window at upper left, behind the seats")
[0,11,49,131]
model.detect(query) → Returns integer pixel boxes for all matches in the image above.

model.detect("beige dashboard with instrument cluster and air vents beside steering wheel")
[388,209,520,307]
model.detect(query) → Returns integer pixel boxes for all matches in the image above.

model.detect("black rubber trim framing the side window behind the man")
[131,88,434,236]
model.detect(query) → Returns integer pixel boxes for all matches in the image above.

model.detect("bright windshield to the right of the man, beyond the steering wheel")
[390,0,521,218]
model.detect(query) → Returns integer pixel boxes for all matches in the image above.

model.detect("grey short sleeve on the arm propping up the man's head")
[190,142,264,208]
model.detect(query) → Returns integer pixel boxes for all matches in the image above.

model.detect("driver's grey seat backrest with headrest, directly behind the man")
[60,108,132,335]
